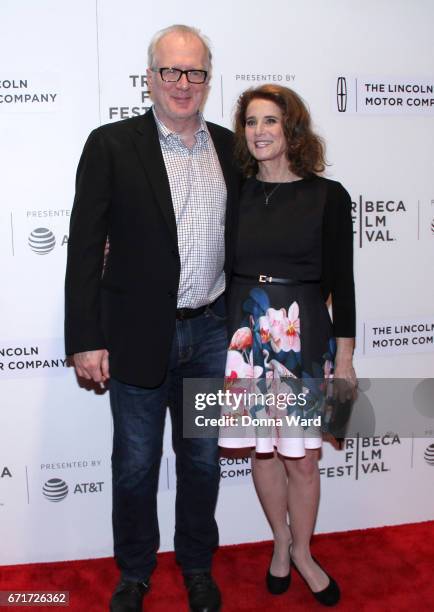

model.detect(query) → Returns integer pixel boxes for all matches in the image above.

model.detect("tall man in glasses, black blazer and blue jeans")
[66,26,238,612]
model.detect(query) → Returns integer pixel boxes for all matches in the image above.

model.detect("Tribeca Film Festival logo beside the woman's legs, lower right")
[320,434,401,480]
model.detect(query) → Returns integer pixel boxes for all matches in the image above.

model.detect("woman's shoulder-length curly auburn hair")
[235,85,326,178]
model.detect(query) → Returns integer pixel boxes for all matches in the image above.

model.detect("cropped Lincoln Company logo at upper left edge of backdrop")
[0,74,60,113]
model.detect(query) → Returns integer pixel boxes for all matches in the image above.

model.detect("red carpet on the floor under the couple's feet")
[0,521,434,612]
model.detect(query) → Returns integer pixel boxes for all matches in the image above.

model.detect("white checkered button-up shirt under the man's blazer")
[152,107,227,308]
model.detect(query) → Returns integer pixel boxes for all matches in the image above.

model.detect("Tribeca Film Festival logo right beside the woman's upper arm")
[351,195,407,248]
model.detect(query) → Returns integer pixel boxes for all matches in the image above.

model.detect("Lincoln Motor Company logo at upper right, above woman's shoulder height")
[334,75,434,115]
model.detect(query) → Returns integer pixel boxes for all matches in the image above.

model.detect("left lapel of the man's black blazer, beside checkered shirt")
[132,111,178,244]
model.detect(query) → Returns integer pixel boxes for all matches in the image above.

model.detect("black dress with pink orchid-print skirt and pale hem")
[219,176,354,457]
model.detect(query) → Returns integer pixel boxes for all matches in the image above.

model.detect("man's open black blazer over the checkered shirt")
[65,111,239,387]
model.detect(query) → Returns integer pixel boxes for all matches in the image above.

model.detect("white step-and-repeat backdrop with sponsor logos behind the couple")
[0,0,434,564]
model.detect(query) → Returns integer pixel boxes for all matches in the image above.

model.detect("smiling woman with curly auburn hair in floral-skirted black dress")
[220,85,356,605]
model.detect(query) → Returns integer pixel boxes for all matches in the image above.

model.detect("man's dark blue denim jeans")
[110,298,227,581]
